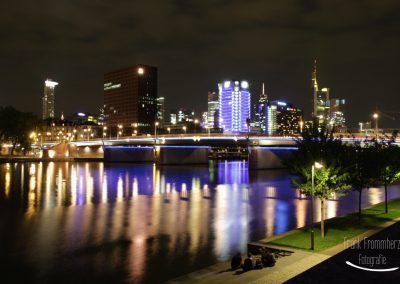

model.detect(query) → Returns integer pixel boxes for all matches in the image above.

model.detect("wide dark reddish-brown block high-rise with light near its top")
[104,64,157,129]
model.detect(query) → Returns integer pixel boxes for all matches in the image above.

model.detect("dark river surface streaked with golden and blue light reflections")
[0,161,400,283]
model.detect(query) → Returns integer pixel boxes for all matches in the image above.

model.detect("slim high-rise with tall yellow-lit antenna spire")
[311,60,329,124]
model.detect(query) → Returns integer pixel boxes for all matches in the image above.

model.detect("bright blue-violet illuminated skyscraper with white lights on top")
[218,81,250,132]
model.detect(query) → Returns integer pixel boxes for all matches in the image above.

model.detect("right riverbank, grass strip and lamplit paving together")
[168,199,400,284]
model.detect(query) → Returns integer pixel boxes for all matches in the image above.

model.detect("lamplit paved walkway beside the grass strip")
[167,216,400,284]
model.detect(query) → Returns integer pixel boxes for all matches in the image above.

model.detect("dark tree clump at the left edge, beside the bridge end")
[0,106,40,155]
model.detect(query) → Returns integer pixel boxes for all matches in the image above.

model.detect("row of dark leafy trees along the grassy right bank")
[285,123,400,238]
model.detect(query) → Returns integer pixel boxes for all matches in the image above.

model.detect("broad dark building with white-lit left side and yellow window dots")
[265,101,303,136]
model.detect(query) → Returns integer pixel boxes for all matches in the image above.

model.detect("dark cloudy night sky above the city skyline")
[0,0,400,127]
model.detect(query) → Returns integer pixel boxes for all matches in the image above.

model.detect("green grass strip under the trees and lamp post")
[268,199,400,251]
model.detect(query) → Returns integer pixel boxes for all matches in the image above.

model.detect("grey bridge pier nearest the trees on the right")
[249,146,297,170]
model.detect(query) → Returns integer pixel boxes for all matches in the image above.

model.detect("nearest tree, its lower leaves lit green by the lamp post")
[285,124,349,238]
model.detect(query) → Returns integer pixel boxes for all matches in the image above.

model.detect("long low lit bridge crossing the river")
[39,134,399,169]
